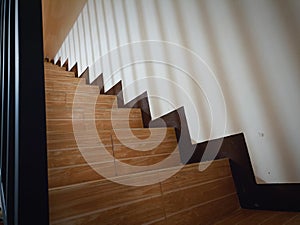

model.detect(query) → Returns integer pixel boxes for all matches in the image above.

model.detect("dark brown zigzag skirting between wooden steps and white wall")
[60,60,300,211]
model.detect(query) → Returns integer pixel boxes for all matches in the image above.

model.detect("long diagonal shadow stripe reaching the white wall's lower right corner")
[228,1,300,179]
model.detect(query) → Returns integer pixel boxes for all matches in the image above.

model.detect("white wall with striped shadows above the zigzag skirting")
[55,0,300,183]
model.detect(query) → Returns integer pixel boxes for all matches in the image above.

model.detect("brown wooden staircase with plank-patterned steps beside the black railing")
[45,63,300,225]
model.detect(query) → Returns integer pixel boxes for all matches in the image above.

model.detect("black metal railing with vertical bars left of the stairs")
[0,0,49,225]
